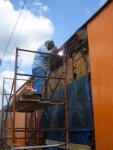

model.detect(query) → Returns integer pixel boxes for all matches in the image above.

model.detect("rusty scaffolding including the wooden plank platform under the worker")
[1,48,69,150]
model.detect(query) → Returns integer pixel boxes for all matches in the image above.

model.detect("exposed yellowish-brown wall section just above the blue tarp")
[47,50,89,93]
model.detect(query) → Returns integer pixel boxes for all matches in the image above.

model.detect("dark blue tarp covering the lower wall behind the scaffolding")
[40,76,93,144]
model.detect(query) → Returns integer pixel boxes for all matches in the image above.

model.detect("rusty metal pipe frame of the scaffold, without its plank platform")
[1,48,69,150]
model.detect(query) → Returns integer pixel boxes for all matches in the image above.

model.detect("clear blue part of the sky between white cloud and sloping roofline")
[11,0,106,47]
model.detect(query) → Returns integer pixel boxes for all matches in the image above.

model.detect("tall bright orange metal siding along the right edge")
[87,1,113,150]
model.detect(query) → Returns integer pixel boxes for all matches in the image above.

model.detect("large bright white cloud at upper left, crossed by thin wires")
[0,0,54,66]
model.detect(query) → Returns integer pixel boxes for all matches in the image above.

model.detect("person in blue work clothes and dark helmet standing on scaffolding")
[32,41,57,96]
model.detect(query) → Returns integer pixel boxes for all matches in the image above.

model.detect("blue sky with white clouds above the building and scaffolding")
[0,0,106,106]
